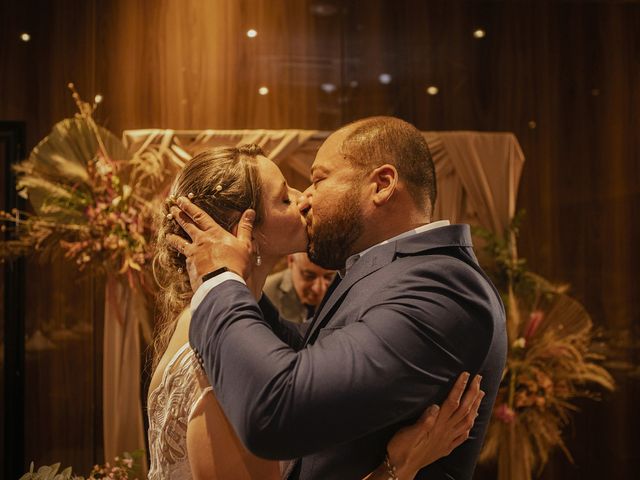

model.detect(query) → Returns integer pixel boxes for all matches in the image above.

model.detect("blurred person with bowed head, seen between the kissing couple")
[264,252,335,323]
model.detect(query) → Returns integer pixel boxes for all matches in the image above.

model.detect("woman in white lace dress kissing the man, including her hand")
[147,145,484,480]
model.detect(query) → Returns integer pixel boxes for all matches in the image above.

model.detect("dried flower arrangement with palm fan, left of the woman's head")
[0,84,170,286]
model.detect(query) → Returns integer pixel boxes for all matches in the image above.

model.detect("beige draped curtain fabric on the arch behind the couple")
[103,129,524,460]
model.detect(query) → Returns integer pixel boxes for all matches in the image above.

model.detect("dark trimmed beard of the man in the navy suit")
[307,189,363,270]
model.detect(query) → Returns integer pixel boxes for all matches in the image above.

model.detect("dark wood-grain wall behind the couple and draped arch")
[0,0,640,479]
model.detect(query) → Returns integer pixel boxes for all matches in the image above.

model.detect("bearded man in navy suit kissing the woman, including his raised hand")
[170,117,507,480]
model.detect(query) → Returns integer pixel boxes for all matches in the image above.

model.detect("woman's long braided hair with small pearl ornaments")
[152,145,264,370]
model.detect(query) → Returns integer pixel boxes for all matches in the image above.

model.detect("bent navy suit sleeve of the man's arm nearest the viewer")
[190,270,491,459]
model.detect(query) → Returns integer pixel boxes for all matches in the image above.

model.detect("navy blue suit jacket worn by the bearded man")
[190,225,507,480]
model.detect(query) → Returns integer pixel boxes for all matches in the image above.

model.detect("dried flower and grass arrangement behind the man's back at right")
[476,215,614,480]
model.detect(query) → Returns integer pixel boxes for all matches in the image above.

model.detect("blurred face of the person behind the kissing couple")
[288,253,335,307]
